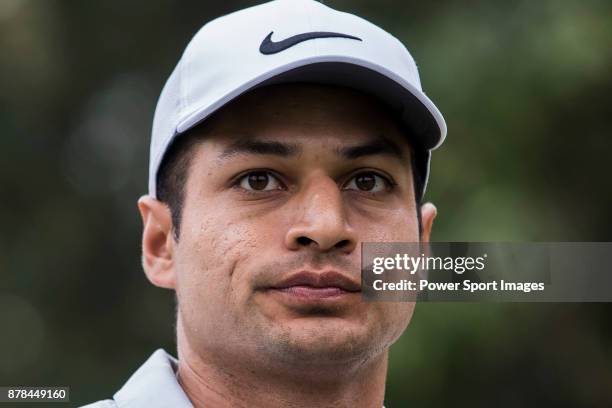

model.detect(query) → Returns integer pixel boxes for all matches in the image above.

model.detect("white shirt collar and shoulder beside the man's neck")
[82,349,193,408]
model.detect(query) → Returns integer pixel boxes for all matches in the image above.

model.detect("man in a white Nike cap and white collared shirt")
[82,0,446,407]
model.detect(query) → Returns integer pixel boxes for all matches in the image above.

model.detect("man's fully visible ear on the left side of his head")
[138,196,176,289]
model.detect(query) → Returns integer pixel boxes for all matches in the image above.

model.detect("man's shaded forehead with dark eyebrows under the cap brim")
[191,84,418,163]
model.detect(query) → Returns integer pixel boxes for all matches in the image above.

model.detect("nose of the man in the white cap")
[285,176,357,253]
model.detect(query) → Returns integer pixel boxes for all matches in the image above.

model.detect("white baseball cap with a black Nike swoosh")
[149,0,446,197]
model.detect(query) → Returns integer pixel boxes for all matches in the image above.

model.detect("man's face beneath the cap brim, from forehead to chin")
[145,85,432,372]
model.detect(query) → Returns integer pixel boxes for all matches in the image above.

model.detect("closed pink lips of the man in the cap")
[270,270,361,298]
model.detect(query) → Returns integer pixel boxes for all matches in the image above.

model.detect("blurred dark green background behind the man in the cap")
[0,0,612,407]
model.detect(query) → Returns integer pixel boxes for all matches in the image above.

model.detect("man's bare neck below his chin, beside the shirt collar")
[178,336,387,408]
